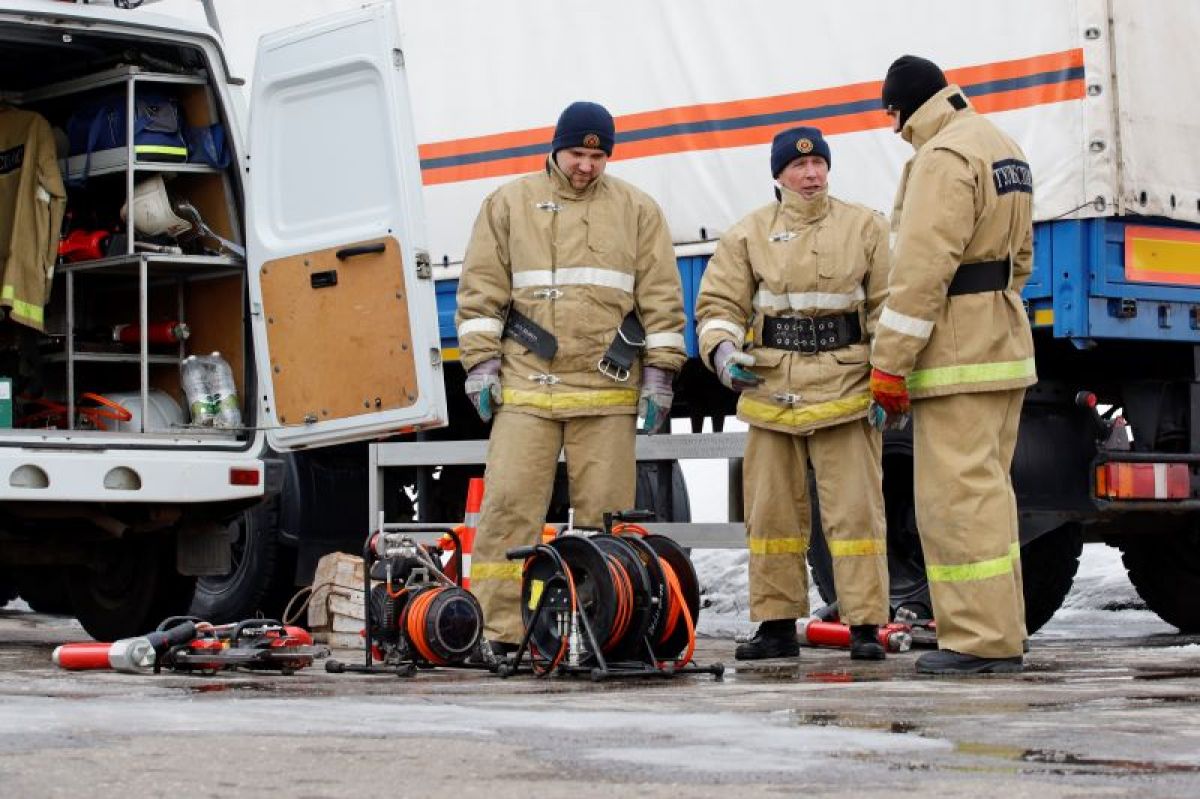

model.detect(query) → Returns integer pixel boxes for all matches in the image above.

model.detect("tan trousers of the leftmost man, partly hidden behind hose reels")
[470,409,637,644]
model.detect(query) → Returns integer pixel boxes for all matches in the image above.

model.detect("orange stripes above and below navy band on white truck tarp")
[419,49,1085,186]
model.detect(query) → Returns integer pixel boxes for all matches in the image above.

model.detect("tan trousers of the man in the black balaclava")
[912,389,1026,657]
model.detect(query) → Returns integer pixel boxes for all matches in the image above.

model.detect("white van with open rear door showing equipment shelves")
[0,0,446,638]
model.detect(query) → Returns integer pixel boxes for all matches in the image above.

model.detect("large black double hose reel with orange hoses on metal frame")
[497,511,725,680]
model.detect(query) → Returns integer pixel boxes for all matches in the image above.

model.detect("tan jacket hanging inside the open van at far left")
[0,103,67,330]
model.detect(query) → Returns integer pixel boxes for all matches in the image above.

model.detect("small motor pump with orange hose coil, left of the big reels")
[325,525,484,677]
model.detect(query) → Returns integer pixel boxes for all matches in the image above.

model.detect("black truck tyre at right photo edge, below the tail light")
[1118,530,1200,632]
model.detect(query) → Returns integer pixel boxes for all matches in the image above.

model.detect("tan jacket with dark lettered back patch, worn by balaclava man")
[871,85,1037,397]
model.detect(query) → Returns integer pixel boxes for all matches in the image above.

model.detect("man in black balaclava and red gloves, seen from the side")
[871,55,1037,674]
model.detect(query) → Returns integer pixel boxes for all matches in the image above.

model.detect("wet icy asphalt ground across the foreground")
[0,611,1200,799]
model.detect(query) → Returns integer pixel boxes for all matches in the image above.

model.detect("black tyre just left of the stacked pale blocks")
[191,498,295,624]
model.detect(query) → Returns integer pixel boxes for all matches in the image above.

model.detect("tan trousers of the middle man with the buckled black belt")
[743,419,890,624]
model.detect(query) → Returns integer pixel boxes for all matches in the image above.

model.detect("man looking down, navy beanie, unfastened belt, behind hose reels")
[456,102,686,656]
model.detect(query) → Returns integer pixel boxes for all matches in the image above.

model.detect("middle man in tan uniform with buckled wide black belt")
[696,127,889,660]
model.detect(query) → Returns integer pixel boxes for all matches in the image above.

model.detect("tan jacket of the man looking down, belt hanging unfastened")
[456,153,686,419]
